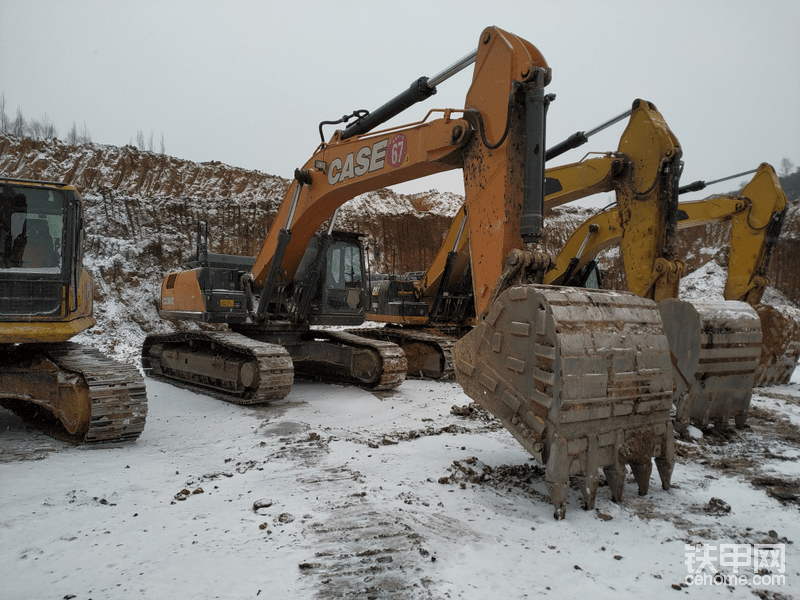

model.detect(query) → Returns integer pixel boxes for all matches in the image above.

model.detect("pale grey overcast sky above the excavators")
[0,0,800,205]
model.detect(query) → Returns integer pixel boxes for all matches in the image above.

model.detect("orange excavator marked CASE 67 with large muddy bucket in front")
[143,27,674,517]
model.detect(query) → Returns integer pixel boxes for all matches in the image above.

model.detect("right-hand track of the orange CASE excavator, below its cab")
[290,329,408,391]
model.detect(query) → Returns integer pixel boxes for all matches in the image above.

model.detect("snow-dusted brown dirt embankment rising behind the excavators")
[0,136,800,352]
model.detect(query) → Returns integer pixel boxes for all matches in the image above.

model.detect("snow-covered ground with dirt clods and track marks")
[0,373,800,600]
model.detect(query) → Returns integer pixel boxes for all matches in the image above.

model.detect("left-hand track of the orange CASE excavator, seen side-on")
[142,331,294,404]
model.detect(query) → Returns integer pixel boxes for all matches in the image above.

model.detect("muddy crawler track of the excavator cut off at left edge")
[3,342,147,445]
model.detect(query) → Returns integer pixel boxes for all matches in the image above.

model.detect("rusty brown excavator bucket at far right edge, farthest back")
[755,304,800,387]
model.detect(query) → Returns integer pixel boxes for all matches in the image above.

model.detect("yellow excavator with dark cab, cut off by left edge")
[0,177,147,444]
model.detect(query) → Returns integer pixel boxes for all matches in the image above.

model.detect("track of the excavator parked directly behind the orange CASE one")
[348,327,458,381]
